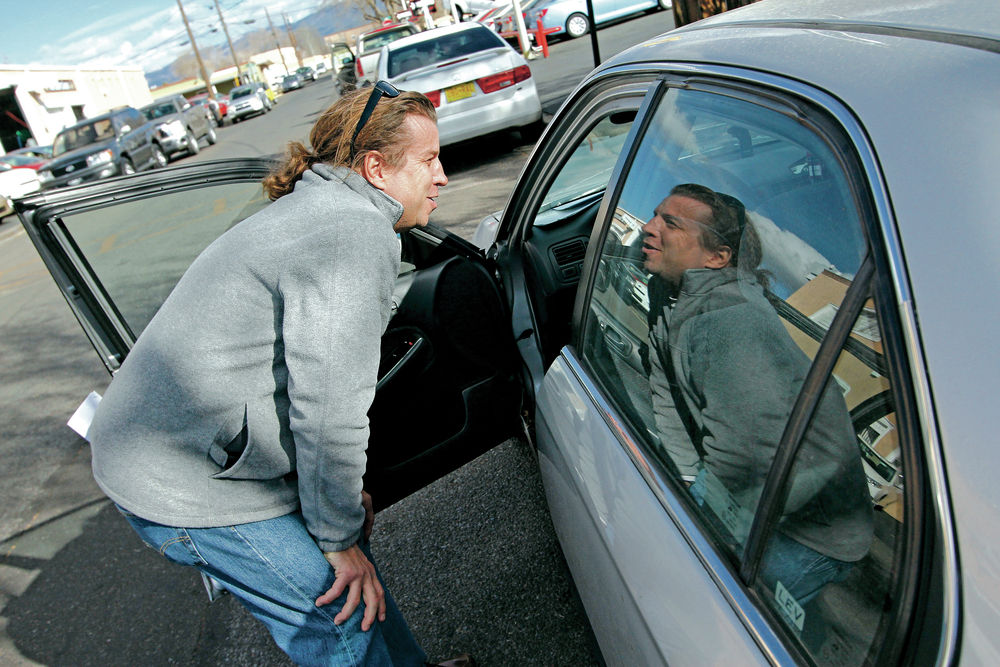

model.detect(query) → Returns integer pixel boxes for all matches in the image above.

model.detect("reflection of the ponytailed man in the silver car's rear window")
[643,184,872,604]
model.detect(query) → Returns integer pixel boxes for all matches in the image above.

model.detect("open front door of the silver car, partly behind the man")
[18,159,521,508]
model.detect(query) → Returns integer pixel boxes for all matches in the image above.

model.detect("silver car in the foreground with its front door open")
[18,0,1000,665]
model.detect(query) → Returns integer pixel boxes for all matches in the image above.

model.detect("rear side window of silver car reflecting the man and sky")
[582,86,916,664]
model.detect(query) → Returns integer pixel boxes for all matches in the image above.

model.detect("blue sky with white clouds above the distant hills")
[0,0,336,72]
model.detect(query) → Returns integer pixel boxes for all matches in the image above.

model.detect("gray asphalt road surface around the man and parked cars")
[0,12,671,666]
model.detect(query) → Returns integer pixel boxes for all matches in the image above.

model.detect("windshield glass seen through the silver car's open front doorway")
[535,112,635,226]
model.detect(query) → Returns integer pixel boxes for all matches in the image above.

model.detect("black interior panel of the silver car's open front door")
[365,256,521,508]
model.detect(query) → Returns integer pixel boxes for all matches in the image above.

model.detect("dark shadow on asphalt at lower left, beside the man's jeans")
[0,501,289,667]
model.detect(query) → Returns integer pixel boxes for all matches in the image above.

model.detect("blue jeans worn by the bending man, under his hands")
[119,508,426,667]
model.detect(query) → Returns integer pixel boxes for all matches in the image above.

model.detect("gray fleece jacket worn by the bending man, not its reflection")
[88,165,403,551]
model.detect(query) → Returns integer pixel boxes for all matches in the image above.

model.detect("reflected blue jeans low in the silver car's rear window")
[760,531,854,605]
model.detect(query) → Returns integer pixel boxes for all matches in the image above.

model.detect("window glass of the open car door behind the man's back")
[62,182,268,336]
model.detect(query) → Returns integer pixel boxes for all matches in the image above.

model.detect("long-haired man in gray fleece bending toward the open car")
[88,82,470,665]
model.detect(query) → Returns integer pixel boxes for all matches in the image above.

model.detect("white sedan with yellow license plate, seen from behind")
[378,23,542,146]
